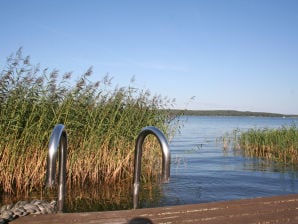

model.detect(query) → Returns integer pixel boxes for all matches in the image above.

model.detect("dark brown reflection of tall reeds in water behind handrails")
[11,180,162,213]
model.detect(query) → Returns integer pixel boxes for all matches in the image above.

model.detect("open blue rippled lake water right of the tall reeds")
[157,116,298,206]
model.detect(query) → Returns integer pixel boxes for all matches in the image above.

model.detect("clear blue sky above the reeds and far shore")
[0,0,298,114]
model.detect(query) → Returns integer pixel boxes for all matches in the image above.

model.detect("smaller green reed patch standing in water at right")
[238,125,298,166]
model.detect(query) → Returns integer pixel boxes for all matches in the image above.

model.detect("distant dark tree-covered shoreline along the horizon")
[171,109,298,117]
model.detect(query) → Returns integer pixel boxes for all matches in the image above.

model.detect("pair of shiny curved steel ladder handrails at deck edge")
[46,124,171,212]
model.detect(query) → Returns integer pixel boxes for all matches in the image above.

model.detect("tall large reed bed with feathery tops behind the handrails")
[0,49,177,194]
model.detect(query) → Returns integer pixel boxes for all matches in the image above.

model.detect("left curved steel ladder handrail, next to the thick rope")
[46,124,67,212]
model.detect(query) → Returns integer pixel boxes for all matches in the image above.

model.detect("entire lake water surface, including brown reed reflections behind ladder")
[0,116,298,212]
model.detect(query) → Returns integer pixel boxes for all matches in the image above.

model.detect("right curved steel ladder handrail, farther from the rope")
[133,126,171,209]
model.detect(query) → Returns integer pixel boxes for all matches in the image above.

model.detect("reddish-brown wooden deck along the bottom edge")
[11,194,298,224]
